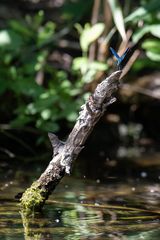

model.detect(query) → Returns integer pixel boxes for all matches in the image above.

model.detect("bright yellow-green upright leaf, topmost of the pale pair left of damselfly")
[80,23,105,52]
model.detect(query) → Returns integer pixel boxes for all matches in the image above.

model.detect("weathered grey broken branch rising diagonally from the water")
[21,71,122,212]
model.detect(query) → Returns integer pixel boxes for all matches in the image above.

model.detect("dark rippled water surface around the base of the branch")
[0,165,160,240]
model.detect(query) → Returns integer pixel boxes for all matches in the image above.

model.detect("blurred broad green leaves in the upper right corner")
[125,0,160,68]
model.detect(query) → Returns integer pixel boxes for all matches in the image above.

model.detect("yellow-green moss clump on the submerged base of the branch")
[20,181,46,214]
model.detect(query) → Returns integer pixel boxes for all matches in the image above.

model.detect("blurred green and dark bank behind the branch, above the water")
[0,0,160,176]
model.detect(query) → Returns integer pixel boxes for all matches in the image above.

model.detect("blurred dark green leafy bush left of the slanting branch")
[0,11,85,131]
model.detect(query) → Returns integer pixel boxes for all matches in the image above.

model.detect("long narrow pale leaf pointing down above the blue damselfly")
[108,0,126,41]
